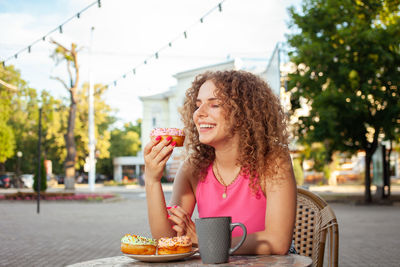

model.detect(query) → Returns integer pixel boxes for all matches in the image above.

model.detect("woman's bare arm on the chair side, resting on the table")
[233,153,297,255]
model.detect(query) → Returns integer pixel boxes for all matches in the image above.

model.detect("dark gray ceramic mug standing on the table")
[195,217,247,263]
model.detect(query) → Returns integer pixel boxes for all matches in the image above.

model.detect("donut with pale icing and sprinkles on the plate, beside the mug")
[157,236,192,255]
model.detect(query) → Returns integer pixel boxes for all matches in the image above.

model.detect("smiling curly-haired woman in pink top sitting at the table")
[144,71,296,254]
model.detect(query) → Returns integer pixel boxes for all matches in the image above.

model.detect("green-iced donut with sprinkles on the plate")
[121,234,157,255]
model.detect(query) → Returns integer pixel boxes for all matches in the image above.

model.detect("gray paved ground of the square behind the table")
[0,188,400,266]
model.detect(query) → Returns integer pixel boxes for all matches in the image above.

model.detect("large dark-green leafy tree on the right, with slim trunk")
[288,0,400,202]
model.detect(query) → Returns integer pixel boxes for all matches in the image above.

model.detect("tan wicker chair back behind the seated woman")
[293,188,339,267]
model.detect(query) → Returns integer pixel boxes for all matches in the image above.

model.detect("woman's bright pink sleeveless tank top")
[196,164,267,237]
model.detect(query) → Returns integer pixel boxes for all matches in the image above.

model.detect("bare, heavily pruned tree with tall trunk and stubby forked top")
[51,40,79,189]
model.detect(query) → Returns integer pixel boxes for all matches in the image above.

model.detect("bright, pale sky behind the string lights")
[0,0,301,124]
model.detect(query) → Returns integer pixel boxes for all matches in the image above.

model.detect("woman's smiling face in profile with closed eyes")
[193,80,236,151]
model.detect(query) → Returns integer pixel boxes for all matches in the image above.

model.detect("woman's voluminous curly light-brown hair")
[180,70,288,192]
